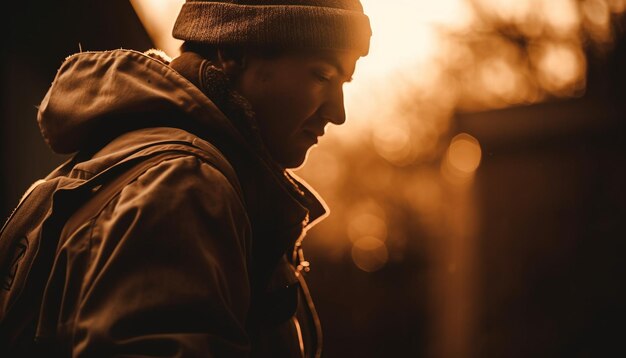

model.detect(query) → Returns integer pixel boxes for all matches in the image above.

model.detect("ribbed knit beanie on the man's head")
[173,0,372,56]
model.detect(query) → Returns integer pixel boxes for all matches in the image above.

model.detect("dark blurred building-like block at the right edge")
[448,16,626,358]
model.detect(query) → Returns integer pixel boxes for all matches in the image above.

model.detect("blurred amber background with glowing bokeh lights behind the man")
[0,0,626,358]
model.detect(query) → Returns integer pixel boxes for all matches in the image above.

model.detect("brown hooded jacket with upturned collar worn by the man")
[31,50,326,357]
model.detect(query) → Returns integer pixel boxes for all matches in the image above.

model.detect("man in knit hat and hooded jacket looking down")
[3,0,371,357]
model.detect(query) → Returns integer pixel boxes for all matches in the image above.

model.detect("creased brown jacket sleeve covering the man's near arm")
[72,157,250,357]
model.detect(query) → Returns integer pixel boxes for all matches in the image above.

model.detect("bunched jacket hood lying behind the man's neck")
[37,50,241,154]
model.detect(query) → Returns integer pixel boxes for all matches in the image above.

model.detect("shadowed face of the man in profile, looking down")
[237,50,359,168]
